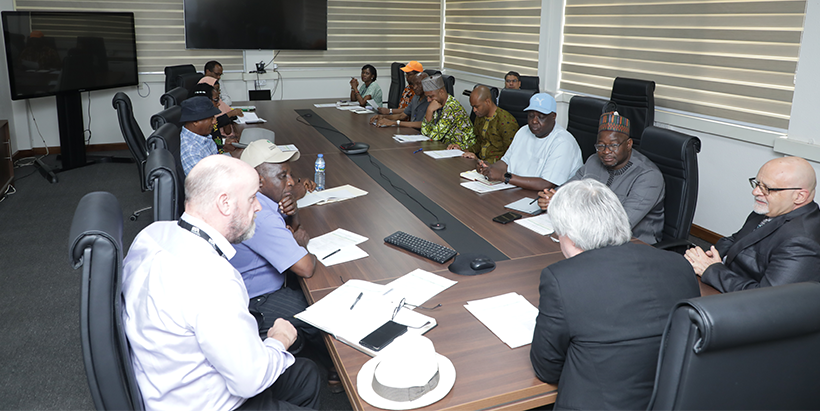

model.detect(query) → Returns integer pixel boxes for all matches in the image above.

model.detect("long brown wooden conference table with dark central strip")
[242,100,716,410]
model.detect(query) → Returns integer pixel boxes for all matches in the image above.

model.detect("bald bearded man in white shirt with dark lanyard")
[122,156,319,411]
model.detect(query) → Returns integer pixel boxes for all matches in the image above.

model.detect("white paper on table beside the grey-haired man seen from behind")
[464,293,538,348]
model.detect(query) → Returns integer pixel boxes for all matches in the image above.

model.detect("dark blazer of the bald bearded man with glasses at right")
[702,202,820,292]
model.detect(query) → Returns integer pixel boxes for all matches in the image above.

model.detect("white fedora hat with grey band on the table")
[357,334,456,410]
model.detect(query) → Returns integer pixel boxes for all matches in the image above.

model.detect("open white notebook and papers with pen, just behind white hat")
[295,280,436,356]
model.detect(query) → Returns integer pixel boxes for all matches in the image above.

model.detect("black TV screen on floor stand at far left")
[2,11,139,100]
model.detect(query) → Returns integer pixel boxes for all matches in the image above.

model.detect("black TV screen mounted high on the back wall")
[183,0,327,50]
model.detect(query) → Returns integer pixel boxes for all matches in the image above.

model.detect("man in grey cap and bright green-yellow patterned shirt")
[421,74,475,150]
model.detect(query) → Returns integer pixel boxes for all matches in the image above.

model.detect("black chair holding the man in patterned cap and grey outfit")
[639,126,700,252]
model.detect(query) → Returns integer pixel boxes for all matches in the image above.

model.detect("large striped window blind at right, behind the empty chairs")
[561,0,805,129]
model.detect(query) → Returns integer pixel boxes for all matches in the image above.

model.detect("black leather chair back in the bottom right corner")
[648,283,820,410]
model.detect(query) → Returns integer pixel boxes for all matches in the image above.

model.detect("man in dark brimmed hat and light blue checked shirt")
[179,96,242,176]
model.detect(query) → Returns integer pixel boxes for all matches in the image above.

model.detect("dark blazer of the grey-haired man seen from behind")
[530,243,700,410]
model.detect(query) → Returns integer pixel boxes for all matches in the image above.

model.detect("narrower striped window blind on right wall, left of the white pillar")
[444,0,541,78]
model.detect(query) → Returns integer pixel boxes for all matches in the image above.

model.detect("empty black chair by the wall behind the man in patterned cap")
[610,77,655,148]
